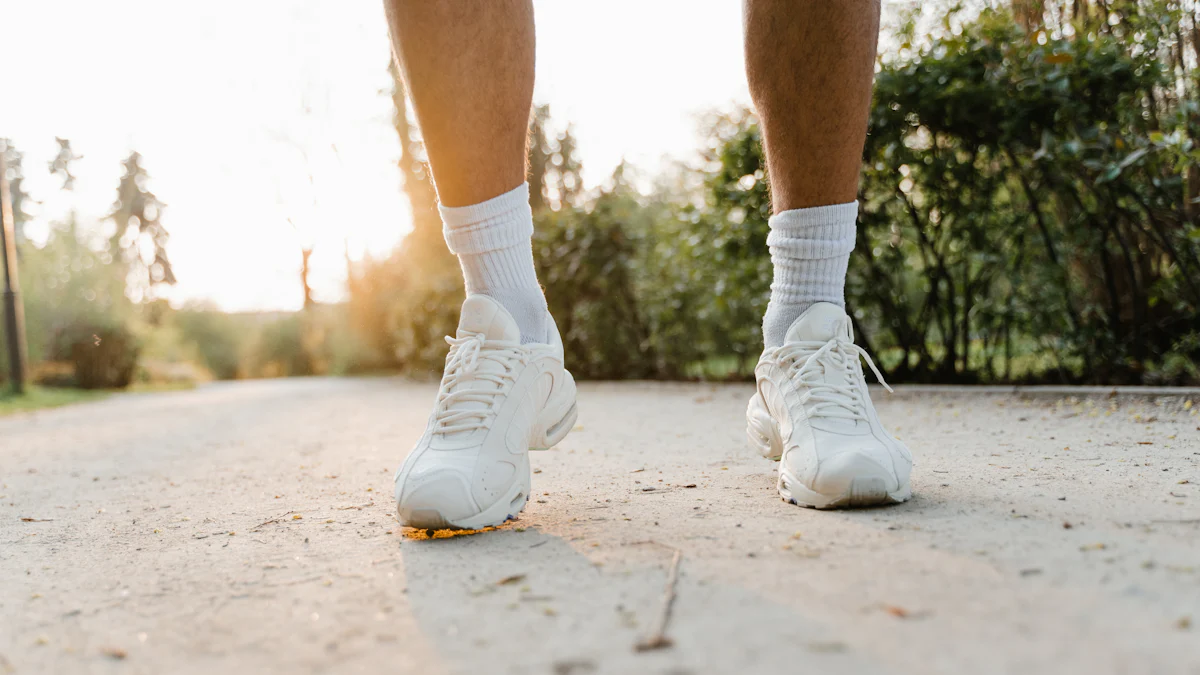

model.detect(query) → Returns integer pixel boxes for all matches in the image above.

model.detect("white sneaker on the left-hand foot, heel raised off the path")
[395,295,577,530]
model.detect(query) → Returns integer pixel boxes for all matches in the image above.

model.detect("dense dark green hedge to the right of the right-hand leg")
[848,7,1200,382]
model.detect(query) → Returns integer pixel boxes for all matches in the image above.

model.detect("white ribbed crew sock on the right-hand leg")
[762,202,858,348]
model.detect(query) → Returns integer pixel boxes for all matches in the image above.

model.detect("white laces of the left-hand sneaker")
[433,334,529,434]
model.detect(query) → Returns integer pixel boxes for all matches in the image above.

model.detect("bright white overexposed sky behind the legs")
[0,0,907,311]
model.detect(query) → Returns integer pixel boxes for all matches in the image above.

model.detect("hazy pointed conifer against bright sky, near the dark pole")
[108,151,175,301]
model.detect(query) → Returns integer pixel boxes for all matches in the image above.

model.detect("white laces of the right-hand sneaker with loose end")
[776,338,892,420]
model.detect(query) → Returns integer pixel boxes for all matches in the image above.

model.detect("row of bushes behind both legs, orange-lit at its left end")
[352,7,1200,383]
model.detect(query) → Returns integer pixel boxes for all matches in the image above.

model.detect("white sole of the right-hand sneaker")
[746,394,912,509]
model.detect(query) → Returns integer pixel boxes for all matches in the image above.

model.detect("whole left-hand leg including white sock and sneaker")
[384,0,576,530]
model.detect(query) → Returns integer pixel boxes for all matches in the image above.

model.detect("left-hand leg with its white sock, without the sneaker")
[384,0,550,342]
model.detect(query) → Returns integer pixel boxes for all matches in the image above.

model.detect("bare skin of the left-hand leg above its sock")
[384,0,534,207]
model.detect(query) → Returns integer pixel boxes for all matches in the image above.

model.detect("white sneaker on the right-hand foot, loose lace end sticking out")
[746,303,912,508]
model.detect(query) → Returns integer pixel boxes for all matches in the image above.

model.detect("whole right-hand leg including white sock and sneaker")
[745,0,912,508]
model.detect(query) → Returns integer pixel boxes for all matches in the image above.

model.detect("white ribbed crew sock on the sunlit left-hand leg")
[438,183,550,344]
